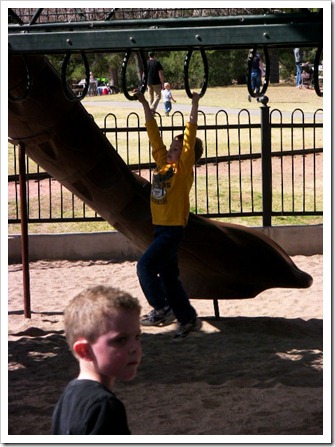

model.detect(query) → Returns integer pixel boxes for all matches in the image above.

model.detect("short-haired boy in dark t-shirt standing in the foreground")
[52,286,142,436]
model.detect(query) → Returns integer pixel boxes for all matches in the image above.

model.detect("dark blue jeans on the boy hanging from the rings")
[137,225,196,324]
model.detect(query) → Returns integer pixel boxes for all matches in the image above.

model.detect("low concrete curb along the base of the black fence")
[8,225,323,264]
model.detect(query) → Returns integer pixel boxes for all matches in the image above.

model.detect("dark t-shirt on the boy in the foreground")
[52,379,130,435]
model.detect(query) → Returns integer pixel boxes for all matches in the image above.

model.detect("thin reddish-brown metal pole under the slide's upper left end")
[19,144,31,318]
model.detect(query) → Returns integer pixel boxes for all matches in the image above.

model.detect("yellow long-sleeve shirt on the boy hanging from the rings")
[146,119,197,227]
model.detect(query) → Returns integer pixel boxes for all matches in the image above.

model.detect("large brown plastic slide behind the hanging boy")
[8,55,313,299]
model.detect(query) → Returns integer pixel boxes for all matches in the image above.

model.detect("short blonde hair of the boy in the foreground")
[64,285,141,352]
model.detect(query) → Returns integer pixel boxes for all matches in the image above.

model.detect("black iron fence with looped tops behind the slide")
[8,106,323,226]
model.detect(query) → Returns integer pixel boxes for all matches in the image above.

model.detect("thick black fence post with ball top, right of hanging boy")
[261,105,272,227]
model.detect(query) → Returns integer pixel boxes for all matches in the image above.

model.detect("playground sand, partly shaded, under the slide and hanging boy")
[8,255,323,443]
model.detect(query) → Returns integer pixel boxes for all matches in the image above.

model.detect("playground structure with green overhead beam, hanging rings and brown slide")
[9,11,322,315]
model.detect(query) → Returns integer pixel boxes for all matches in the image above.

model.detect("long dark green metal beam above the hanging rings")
[8,21,323,54]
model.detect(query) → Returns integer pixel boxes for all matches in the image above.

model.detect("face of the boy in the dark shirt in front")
[91,310,142,386]
